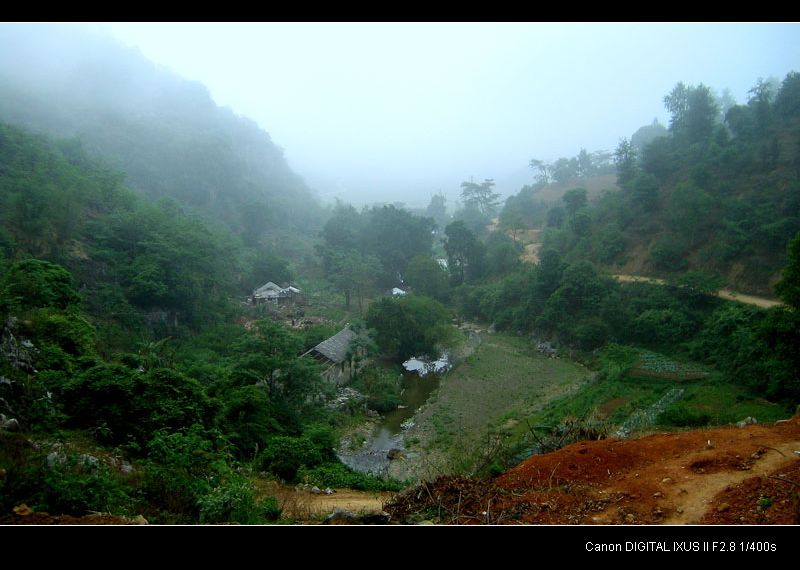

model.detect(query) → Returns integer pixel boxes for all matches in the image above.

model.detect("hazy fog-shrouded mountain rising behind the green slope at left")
[0,24,319,237]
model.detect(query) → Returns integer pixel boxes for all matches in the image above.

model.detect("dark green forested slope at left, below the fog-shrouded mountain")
[0,125,400,522]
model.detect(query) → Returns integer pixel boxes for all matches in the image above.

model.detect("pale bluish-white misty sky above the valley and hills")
[106,23,800,206]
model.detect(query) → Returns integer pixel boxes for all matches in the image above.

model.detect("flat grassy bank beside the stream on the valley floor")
[390,334,591,479]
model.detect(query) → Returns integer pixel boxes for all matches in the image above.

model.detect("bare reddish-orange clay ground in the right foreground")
[386,416,800,524]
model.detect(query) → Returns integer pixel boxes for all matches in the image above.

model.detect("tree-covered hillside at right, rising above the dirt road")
[501,72,800,295]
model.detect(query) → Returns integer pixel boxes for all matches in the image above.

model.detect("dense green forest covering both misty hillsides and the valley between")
[0,27,800,523]
